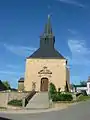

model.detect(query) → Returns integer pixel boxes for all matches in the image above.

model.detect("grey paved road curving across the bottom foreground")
[0,101,90,120]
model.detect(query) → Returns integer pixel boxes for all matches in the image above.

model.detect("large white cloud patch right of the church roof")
[68,40,90,65]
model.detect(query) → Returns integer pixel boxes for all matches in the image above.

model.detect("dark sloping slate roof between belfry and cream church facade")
[28,48,65,59]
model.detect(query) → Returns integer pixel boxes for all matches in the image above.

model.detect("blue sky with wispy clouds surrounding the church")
[0,0,90,88]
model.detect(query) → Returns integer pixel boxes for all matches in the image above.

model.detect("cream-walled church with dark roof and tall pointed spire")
[24,15,70,92]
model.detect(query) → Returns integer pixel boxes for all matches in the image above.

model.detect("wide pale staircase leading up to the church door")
[26,92,49,109]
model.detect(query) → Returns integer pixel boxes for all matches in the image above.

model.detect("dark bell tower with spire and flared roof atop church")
[28,15,65,59]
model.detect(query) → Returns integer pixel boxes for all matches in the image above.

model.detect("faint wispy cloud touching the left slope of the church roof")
[4,44,36,57]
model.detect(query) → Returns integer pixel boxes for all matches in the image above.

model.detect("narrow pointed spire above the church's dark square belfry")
[44,14,53,36]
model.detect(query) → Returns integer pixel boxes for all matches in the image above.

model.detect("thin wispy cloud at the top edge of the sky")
[58,0,85,8]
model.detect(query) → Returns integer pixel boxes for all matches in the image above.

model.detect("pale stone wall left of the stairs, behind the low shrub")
[0,92,29,107]
